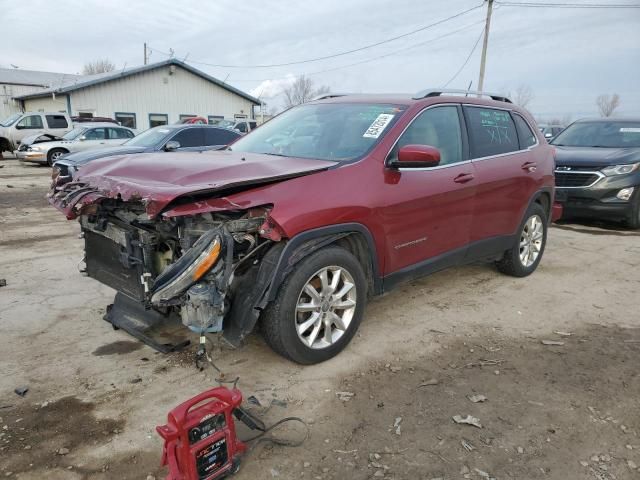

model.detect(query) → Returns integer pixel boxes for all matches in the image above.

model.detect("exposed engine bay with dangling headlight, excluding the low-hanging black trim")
[80,199,274,343]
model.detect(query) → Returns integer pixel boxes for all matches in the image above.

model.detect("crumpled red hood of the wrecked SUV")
[50,151,336,218]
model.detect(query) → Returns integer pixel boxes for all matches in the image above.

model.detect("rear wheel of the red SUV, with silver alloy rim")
[496,203,548,277]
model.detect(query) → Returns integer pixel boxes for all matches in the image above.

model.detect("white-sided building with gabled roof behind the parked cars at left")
[13,59,260,130]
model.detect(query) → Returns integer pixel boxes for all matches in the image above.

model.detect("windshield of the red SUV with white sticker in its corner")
[230,103,406,162]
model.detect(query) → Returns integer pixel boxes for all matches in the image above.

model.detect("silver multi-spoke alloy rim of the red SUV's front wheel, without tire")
[295,266,357,349]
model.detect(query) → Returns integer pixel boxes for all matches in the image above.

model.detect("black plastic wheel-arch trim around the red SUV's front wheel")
[223,223,382,347]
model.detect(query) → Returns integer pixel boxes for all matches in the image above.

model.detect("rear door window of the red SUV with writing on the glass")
[465,107,520,158]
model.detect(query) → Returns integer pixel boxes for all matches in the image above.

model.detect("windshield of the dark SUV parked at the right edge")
[551,120,640,148]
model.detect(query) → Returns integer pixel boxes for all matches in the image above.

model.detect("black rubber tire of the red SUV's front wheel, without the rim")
[262,246,367,365]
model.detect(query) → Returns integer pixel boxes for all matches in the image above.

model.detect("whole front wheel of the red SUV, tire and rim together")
[262,247,367,364]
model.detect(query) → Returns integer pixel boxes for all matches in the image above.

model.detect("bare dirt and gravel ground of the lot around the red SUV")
[0,160,640,480]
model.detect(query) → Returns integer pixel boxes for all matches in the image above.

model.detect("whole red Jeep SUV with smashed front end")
[50,91,554,364]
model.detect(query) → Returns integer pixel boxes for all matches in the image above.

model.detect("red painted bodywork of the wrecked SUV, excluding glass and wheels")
[52,96,555,276]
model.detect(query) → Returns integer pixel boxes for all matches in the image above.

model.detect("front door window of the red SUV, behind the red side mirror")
[388,105,463,165]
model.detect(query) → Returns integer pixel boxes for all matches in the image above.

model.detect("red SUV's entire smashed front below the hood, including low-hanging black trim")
[65,191,280,351]
